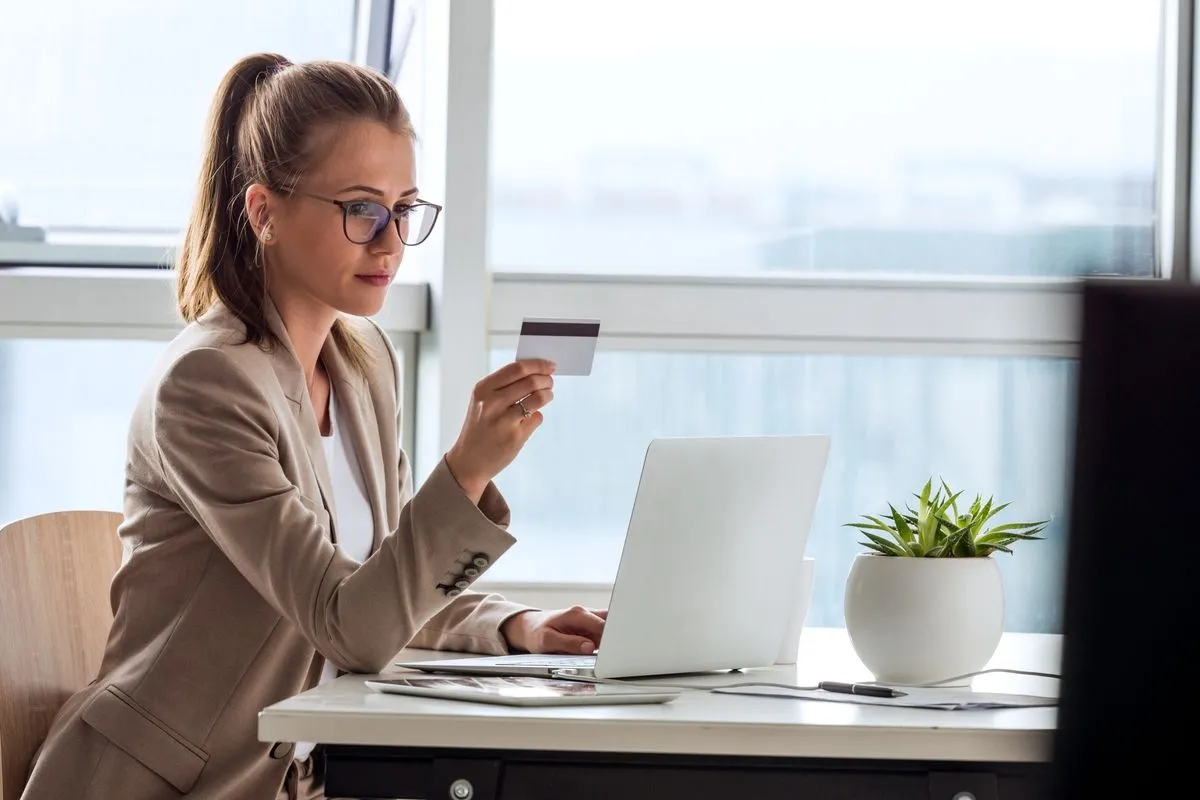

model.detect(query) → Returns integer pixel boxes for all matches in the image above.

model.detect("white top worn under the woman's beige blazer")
[295,387,374,760]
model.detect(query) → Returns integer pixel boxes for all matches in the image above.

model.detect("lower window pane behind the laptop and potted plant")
[490,350,1074,631]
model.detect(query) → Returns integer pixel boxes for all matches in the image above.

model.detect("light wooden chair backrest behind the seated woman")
[0,511,121,800]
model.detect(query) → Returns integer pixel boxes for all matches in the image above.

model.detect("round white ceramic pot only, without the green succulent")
[845,553,1004,685]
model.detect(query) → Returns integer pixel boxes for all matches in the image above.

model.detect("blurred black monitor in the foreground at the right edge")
[1051,279,1200,800]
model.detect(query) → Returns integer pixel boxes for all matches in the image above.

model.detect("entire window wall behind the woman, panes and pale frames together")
[0,0,1180,631]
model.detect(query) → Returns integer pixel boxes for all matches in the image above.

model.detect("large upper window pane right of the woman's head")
[491,0,1162,276]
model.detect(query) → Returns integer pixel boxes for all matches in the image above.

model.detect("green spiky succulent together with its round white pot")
[845,479,1049,686]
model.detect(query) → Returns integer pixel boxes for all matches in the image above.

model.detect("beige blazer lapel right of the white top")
[320,336,386,553]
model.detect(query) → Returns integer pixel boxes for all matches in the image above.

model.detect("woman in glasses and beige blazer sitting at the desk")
[24,54,604,800]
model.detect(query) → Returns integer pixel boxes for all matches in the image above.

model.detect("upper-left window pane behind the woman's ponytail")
[0,0,355,246]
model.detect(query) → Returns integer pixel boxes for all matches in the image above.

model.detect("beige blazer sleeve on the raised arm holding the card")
[154,348,514,673]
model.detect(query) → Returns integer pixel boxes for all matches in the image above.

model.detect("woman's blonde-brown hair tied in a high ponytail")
[175,53,415,372]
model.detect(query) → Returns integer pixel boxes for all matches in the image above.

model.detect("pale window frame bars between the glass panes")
[0,0,1200,606]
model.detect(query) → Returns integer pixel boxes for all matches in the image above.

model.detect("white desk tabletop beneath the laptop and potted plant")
[270,628,1061,763]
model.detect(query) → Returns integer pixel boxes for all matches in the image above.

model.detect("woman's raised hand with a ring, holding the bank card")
[445,359,554,503]
